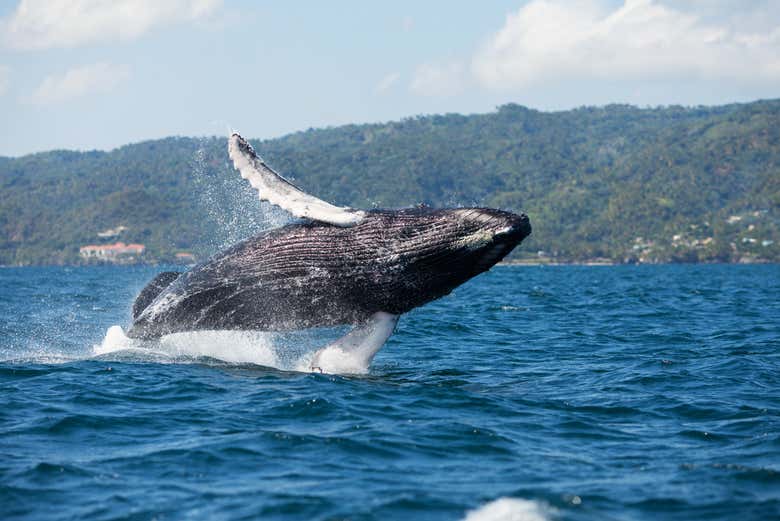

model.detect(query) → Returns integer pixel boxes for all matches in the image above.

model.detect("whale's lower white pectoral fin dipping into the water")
[310,311,398,373]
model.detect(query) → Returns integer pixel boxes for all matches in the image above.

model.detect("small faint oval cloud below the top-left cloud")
[25,63,130,105]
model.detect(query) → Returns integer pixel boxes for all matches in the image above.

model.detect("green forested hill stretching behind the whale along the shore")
[0,100,780,265]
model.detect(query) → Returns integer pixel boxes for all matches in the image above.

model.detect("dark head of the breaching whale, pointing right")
[368,208,531,308]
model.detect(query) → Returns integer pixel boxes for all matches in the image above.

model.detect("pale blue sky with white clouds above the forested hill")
[0,0,780,156]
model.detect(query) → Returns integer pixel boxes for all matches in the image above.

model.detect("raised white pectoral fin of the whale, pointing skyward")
[228,132,365,226]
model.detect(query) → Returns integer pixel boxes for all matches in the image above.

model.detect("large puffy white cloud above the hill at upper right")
[471,0,780,89]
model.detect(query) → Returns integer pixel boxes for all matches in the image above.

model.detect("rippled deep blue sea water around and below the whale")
[0,266,780,520]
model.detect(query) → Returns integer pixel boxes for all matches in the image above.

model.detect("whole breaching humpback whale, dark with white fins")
[128,133,531,372]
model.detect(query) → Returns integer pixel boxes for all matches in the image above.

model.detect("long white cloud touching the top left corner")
[0,0,222,50]
